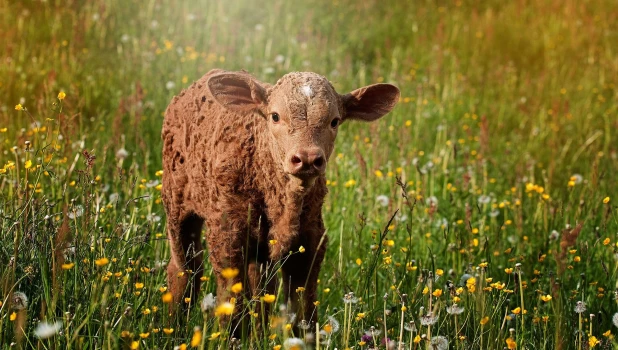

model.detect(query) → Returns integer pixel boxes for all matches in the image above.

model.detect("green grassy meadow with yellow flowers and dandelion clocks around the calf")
[0,0,618,350]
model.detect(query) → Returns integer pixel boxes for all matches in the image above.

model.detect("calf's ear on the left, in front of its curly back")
[208,72,267,111]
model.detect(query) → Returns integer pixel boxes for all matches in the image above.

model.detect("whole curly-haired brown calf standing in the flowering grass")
[162,70,399,334]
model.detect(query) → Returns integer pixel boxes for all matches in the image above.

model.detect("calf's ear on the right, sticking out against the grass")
[341,84,399,122]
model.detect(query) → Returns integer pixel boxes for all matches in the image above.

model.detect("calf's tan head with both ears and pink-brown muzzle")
[208,72,399,184]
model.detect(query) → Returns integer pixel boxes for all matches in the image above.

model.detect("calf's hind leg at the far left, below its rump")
[167,213,204,304]
